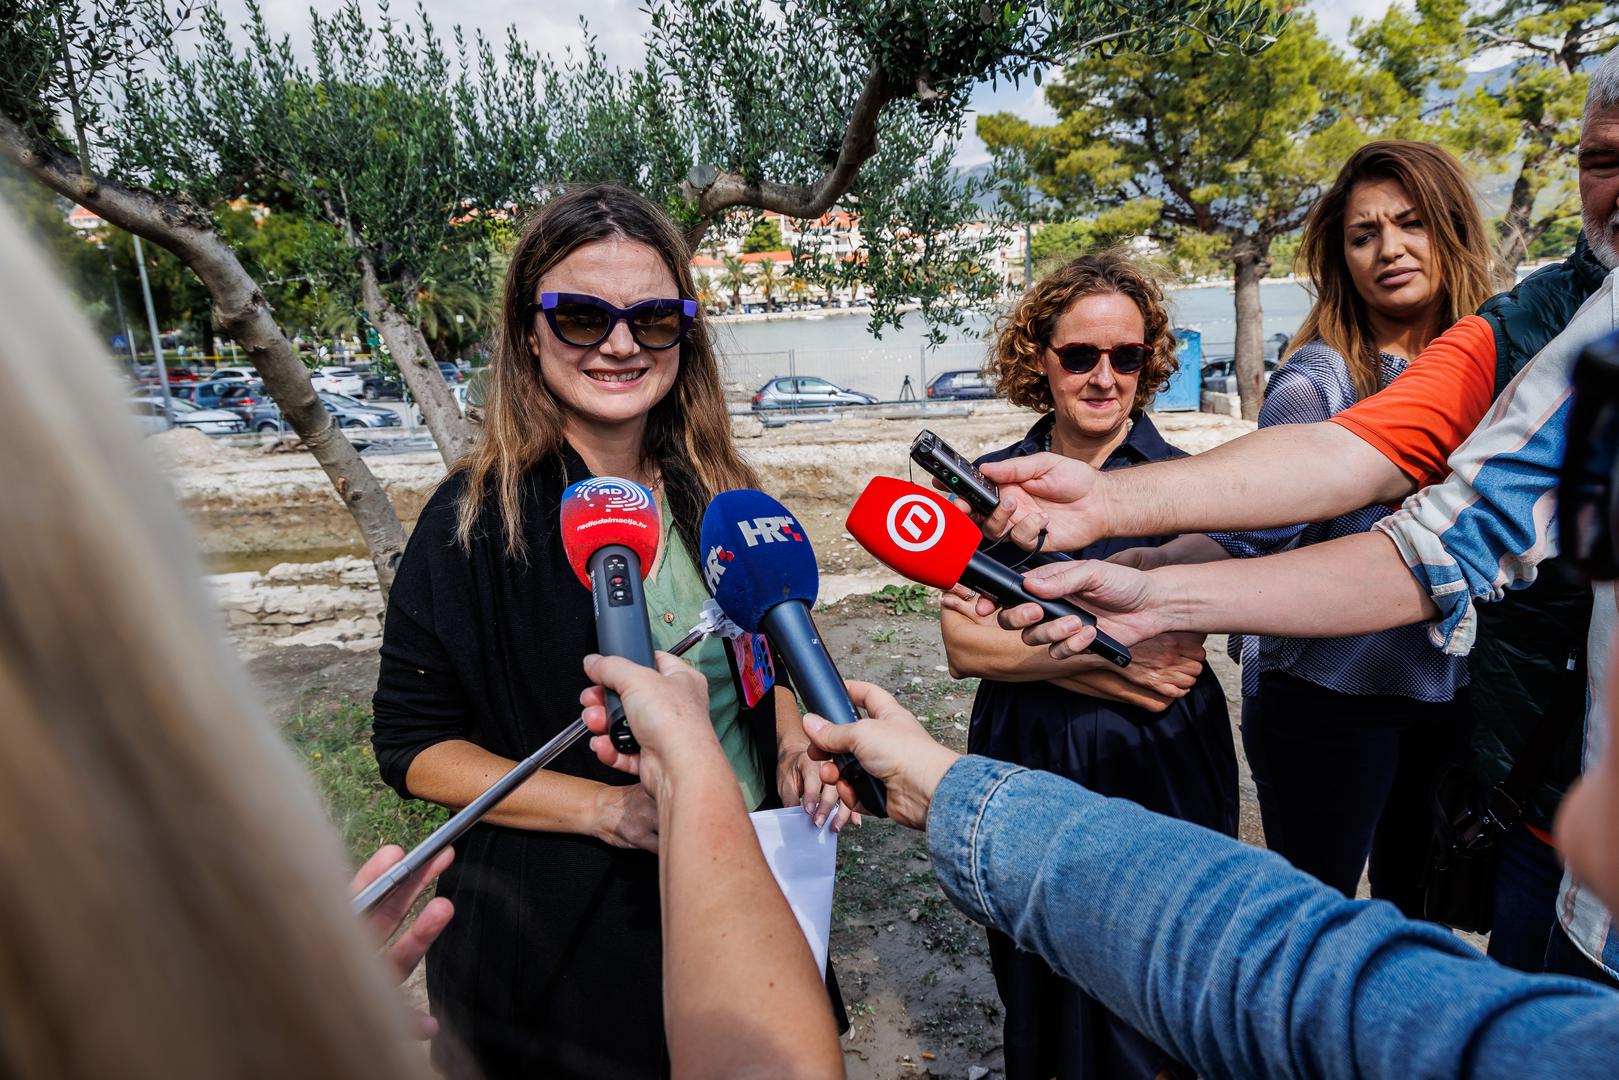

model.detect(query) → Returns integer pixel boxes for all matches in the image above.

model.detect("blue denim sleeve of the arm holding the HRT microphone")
[928,758,1619,1078]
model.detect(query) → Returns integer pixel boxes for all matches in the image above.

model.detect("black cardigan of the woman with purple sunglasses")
[372,449,774,1080]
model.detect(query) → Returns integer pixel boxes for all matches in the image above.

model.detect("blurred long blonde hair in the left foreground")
[0,204,426,1080]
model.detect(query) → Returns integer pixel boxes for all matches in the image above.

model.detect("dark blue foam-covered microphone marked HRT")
[701,491,889,818]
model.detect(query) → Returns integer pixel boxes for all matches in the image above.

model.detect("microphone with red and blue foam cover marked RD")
[562,476,659,755]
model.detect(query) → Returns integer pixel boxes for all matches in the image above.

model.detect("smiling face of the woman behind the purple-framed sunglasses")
[529,236,680,427]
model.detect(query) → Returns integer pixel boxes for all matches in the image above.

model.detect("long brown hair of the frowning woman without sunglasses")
[1287,139,1494,398]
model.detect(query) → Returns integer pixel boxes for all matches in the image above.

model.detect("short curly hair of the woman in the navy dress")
[984,251,1180,413]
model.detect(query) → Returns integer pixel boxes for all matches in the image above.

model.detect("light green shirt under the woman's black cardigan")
[644,502,766,808]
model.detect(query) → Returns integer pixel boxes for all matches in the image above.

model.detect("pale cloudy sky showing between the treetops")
[220,0,1389,168]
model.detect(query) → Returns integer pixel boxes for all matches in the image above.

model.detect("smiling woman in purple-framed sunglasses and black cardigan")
[374,185,850,1080]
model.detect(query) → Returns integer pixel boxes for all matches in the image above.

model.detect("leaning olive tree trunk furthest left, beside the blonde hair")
[0,115,404,599]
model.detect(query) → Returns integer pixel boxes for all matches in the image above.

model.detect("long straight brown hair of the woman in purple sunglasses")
[455,185,758,559]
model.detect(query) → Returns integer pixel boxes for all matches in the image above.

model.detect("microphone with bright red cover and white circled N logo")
[843,476,1130,667]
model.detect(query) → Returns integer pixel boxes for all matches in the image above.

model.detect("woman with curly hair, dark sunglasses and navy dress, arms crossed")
[942,254,1237,1080]
